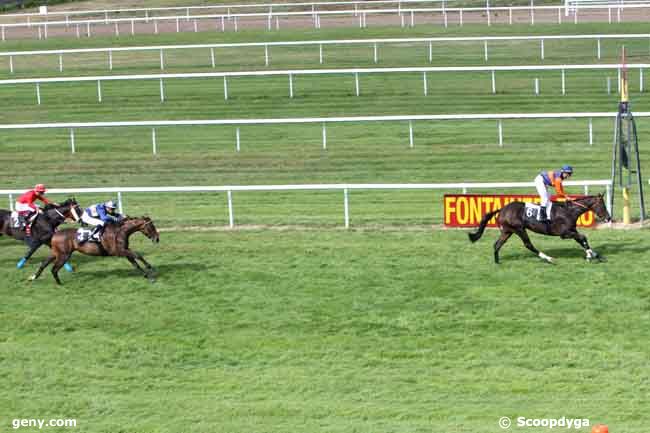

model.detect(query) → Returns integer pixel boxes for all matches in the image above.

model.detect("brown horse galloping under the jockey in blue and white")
[30,217,160,284]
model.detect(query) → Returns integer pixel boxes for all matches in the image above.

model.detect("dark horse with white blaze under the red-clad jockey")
[0,198,83,268]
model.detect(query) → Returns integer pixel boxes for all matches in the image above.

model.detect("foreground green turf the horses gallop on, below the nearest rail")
[0,230,650,433]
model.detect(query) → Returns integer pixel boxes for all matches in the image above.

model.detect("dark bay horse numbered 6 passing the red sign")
[469,194,611,263]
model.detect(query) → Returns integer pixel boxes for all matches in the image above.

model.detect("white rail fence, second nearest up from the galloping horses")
[0,112,650,155]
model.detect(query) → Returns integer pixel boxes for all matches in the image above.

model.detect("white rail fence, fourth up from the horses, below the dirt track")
[0,33,650,74]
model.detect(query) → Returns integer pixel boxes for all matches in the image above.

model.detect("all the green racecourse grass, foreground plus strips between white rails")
[0,11,650,433]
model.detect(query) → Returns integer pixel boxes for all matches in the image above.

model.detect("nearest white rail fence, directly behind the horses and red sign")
[0,180,612,228]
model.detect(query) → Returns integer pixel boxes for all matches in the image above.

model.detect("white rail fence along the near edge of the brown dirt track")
[0,3,650,41]
